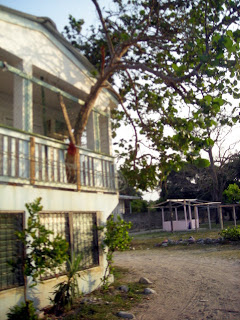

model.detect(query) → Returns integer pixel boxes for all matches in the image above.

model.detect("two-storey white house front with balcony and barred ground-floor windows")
[0,6,118,320]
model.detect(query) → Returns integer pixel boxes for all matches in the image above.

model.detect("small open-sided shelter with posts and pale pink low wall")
[151,199,222,232]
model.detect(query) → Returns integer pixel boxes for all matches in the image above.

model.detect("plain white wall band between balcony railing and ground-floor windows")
[0,185,118,221]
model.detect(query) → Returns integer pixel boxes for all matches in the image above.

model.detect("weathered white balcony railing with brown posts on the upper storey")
[0,127,116,192]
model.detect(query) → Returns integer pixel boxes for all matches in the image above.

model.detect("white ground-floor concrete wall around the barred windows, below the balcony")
[0,185,118,320]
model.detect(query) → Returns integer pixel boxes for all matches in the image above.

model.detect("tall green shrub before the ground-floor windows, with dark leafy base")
[8,198,68,320]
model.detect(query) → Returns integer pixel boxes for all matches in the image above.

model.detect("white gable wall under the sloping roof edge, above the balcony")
[0,11,116,109]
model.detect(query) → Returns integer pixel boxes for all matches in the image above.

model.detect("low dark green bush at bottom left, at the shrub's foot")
[7,301,38,320]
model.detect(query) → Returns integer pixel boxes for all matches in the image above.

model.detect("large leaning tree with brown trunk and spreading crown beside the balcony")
[65,0,240,189]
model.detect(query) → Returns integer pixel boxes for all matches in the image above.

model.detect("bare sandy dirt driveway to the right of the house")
[114,249,240,320]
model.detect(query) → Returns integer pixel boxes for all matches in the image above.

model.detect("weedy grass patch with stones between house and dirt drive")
[45,267,146,320]
